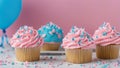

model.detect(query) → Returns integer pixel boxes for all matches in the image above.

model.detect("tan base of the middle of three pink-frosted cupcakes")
[65,49,92,64]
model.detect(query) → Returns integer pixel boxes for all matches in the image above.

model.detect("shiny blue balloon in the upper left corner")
[0,0,22,30]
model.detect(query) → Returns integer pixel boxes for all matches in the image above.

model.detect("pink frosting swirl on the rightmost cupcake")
[93,23,120,46]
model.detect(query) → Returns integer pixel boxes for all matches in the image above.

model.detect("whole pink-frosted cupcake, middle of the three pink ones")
[61,26,94,64]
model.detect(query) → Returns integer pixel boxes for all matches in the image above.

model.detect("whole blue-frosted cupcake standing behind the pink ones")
[38,22,63,51]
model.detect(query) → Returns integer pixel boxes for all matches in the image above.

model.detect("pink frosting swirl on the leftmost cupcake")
[10,26,43,48]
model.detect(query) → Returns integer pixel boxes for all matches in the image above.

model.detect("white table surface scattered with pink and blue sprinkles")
[0,44,120,68]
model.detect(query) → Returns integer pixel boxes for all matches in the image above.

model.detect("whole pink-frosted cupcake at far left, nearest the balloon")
[10,26,43,62]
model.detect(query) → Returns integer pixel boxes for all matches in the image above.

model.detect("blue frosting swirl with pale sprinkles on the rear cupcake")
[38,22,64,43]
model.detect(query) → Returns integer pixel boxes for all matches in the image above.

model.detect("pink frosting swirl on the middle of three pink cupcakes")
[61,26,94,49]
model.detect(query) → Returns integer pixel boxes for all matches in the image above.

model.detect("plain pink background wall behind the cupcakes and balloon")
[0,0,120,36]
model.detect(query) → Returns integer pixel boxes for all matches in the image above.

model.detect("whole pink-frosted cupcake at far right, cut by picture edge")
[93,23,120,59]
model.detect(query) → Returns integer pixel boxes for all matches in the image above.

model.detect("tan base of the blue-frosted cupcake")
[41,43,60,51]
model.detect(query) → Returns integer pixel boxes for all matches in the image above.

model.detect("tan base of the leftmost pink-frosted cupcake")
[15,47,40,62]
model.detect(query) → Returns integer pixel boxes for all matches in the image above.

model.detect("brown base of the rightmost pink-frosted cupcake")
[96,45,119,59]
